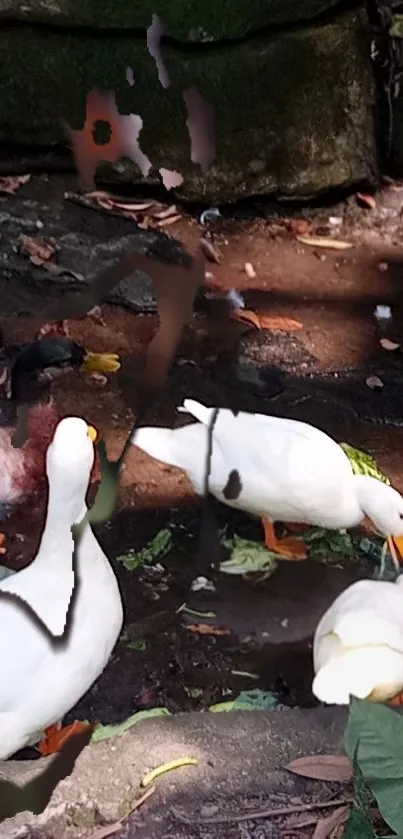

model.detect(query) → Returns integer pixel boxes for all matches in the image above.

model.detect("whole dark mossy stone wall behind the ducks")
[0,0,378,201]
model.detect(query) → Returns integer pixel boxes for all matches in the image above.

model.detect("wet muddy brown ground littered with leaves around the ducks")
[0,177,403,752]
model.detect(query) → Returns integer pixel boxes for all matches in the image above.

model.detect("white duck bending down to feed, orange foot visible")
[132,399,403,566]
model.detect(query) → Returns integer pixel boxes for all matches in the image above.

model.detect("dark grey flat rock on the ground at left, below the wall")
[0,176,200,317]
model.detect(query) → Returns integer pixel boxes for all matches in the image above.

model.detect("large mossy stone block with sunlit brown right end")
[0,11,376,201]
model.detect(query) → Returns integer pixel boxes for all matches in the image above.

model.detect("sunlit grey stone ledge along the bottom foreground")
[0,708,347,839]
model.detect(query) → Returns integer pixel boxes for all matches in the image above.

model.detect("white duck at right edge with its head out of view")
[312,575,403,705]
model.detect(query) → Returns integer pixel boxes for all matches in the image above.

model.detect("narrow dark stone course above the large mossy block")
[0,0,354,41]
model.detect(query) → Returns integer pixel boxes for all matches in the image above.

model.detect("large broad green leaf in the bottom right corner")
[345,699,403,833]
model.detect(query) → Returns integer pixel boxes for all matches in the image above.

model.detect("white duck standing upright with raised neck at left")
[0,417,123,759]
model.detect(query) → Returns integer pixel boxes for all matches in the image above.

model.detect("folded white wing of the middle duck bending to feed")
[183,399,352,527]
